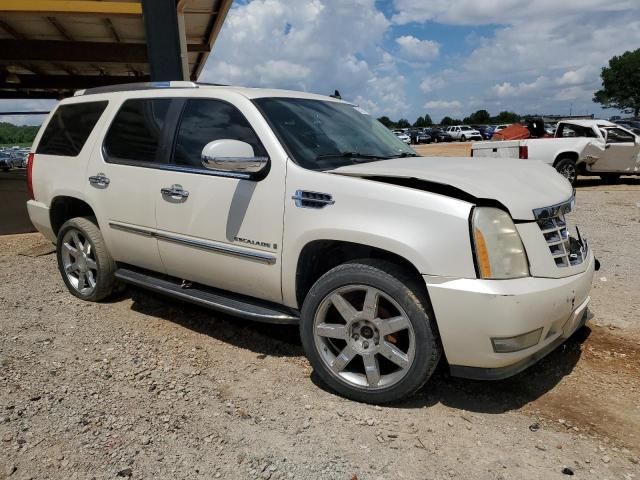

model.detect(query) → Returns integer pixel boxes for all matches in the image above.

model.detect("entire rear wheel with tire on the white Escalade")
[56,217,116,302]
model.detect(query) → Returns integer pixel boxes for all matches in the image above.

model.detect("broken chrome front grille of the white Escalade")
[533,199,587,267]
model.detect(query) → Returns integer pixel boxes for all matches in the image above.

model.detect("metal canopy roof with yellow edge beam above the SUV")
[0,0,233,98]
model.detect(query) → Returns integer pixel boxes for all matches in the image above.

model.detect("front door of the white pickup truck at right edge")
[591,128,640,174]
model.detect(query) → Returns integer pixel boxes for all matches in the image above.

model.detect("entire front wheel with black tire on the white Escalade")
[300,260,442,404]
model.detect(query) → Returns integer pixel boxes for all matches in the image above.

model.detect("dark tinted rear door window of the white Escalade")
[104,98,171,162]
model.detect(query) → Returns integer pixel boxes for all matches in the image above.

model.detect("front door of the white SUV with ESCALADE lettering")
[155,97,286,302]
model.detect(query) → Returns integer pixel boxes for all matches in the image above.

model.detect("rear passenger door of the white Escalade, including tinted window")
[86,98,179,272]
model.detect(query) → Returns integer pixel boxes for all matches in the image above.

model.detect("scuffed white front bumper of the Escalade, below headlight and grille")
[424,252,595,379]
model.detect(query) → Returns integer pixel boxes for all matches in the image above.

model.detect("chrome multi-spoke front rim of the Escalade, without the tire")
[313,285,416,390]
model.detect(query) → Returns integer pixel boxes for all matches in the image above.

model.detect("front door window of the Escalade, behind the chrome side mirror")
[173,99,267,168]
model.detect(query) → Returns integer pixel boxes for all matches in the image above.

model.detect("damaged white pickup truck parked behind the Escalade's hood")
[471,120,640,184]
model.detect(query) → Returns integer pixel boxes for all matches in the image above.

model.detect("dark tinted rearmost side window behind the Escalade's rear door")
[36,101,108,157]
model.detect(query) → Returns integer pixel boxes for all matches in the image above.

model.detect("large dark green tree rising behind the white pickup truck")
[593,48,640,117]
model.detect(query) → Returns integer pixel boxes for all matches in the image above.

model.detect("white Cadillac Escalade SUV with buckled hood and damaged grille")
[23,82,597,403]
